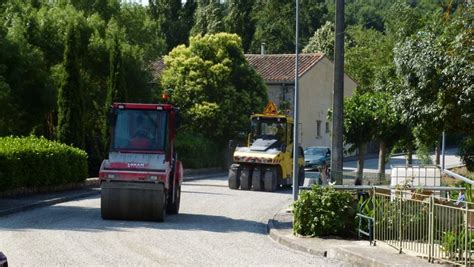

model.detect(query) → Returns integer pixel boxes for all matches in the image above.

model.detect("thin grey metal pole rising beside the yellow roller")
[293,0,299,201]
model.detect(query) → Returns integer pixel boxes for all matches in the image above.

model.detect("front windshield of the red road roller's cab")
[112,110,167,150]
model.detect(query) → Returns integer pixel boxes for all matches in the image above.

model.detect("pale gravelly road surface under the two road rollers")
[0,177,349,266]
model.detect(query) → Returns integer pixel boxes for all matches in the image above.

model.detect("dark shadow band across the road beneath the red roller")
[0,198,266,234]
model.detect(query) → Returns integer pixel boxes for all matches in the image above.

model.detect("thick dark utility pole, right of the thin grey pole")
[331,0,344,184]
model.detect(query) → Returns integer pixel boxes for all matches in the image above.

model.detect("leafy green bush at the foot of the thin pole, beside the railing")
[293,185,356,237]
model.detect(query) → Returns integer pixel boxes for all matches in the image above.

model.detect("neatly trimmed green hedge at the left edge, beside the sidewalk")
[0,136,87,191]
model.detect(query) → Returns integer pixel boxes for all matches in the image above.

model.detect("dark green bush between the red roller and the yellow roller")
[175,132,224,169]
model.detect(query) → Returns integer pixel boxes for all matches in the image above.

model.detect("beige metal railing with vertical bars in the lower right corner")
[372,187,474,266]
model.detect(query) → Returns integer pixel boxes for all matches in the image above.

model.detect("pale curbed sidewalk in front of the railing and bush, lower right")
[267,209,441,266]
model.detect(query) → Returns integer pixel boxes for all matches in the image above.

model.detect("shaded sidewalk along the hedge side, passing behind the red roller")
[0,169,227,217]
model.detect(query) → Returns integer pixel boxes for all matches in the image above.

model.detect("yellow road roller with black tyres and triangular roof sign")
[229,101,304,192]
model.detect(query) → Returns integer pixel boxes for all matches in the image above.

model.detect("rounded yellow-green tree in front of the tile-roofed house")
[161,33,267,145]
